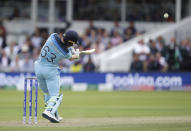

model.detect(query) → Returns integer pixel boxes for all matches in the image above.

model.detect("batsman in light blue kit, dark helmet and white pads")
[35,30,80,123]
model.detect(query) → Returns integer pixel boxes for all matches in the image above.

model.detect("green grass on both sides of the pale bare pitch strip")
[0,90,191,131]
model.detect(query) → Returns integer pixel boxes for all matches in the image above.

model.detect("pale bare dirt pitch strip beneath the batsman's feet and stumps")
[0,116,191,127]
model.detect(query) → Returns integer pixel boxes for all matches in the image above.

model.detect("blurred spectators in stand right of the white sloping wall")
[130,37,191,72]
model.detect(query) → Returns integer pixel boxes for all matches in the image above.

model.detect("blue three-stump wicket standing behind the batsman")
[23,77,38,124]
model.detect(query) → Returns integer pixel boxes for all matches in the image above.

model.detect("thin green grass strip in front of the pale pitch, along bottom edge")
[0,124,191,131]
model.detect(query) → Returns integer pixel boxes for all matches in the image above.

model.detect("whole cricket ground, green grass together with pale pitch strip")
[0,90,191,131]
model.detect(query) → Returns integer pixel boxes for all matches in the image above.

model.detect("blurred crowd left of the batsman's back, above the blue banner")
[0,25,43,72]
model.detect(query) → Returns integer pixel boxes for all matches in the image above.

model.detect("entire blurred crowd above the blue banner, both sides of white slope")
[0,18,191,72]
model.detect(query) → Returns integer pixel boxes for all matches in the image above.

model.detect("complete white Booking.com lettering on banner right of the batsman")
[106,73,182,87]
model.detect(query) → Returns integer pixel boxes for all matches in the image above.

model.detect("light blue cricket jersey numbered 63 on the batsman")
[37,33,72,66]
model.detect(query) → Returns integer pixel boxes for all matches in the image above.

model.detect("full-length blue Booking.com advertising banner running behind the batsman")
[0,73,191,91]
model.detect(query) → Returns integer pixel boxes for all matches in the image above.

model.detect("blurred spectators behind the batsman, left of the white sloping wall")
[0,21,139,72]
